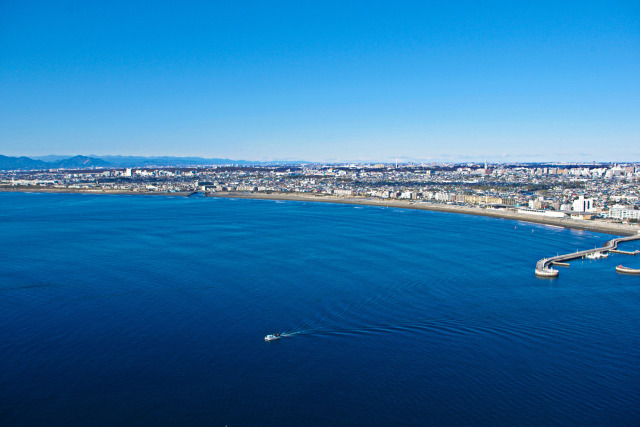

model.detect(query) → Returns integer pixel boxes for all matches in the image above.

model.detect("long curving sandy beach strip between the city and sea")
[0,188,640,236]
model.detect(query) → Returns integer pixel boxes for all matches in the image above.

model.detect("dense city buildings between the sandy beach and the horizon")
[0,163,640,226]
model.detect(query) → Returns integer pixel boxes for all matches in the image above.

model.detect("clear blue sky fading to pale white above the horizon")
[0,0,640,161]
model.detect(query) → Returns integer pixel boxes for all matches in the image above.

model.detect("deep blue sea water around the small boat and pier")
[0,193,640,426]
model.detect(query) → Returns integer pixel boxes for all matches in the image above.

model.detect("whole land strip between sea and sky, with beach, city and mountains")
[0,156,640,229]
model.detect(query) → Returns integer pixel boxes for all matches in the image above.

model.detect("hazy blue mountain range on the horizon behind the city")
[0,155,300,170]
